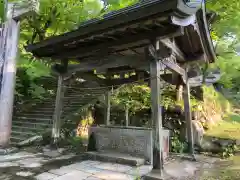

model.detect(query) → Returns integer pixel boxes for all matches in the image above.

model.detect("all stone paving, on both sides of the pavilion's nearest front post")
[0,148,219,180]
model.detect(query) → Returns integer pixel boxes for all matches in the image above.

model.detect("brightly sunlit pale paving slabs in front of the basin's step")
[36,160,152,180]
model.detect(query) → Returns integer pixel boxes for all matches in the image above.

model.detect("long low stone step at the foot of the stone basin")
[86,151,145,167]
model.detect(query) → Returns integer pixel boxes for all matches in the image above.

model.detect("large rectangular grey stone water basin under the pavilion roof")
[88,127,153,162]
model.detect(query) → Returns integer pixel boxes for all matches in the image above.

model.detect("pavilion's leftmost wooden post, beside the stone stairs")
[52,75,64,144]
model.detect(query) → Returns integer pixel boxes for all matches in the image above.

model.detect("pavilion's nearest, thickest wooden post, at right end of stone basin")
[150,46,163,176]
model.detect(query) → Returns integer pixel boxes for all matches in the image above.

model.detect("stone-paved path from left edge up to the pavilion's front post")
[0,151,152,180]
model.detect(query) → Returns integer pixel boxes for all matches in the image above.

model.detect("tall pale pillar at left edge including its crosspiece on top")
[0,1,38,147]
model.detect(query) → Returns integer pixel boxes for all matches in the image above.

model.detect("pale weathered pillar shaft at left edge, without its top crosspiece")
[0,19,20,147]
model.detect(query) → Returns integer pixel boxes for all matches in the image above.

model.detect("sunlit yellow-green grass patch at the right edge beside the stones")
[206,114,240,139]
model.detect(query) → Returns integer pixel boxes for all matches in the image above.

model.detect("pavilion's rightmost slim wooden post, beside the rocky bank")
[183,71,194,155]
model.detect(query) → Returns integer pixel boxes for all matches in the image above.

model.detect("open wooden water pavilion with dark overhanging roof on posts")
[27,0,215,179]
